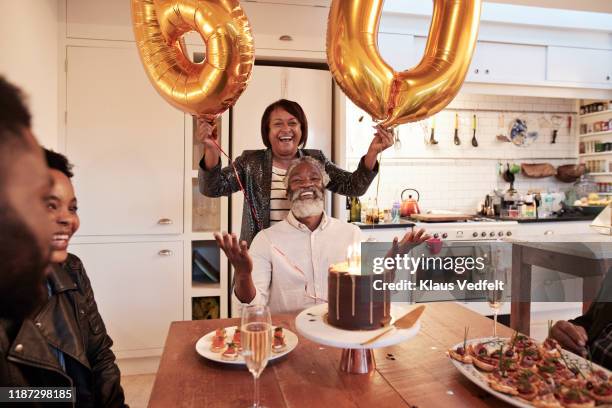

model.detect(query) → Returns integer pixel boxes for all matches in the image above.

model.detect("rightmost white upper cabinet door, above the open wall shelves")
[547,47,612,86]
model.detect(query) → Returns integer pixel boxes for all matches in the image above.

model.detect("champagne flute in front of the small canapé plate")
[240,305,272,408]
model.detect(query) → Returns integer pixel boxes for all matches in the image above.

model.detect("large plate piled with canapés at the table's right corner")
[447,329,612,408]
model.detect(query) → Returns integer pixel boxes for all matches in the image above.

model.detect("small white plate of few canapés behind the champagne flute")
[196,326,298,365]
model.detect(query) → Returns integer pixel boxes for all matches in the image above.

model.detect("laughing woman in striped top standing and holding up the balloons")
[198,99,393,244]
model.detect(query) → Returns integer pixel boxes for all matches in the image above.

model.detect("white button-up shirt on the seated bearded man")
[232,212,361,313]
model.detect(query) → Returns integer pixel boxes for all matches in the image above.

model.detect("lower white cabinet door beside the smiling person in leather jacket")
[70,242,183,356]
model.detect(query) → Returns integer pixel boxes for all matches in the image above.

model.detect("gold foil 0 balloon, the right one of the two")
[327,0,482,127]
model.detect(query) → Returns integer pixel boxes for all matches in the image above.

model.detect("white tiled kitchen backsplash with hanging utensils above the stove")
[346,94,578,213]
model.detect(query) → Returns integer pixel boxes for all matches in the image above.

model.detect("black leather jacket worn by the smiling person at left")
[0,254,126,407]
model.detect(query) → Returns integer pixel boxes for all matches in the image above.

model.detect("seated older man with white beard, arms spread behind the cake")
[215,157,428,313]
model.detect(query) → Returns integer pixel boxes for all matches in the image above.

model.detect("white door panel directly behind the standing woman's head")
[231,65,332,239]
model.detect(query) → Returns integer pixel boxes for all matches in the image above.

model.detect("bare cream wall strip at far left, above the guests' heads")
[0,0,59,149]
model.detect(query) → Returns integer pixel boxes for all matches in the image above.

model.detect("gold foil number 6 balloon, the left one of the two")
[132,0,255,117]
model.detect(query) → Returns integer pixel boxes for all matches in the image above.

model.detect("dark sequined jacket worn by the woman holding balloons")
[198,149,378,245]
